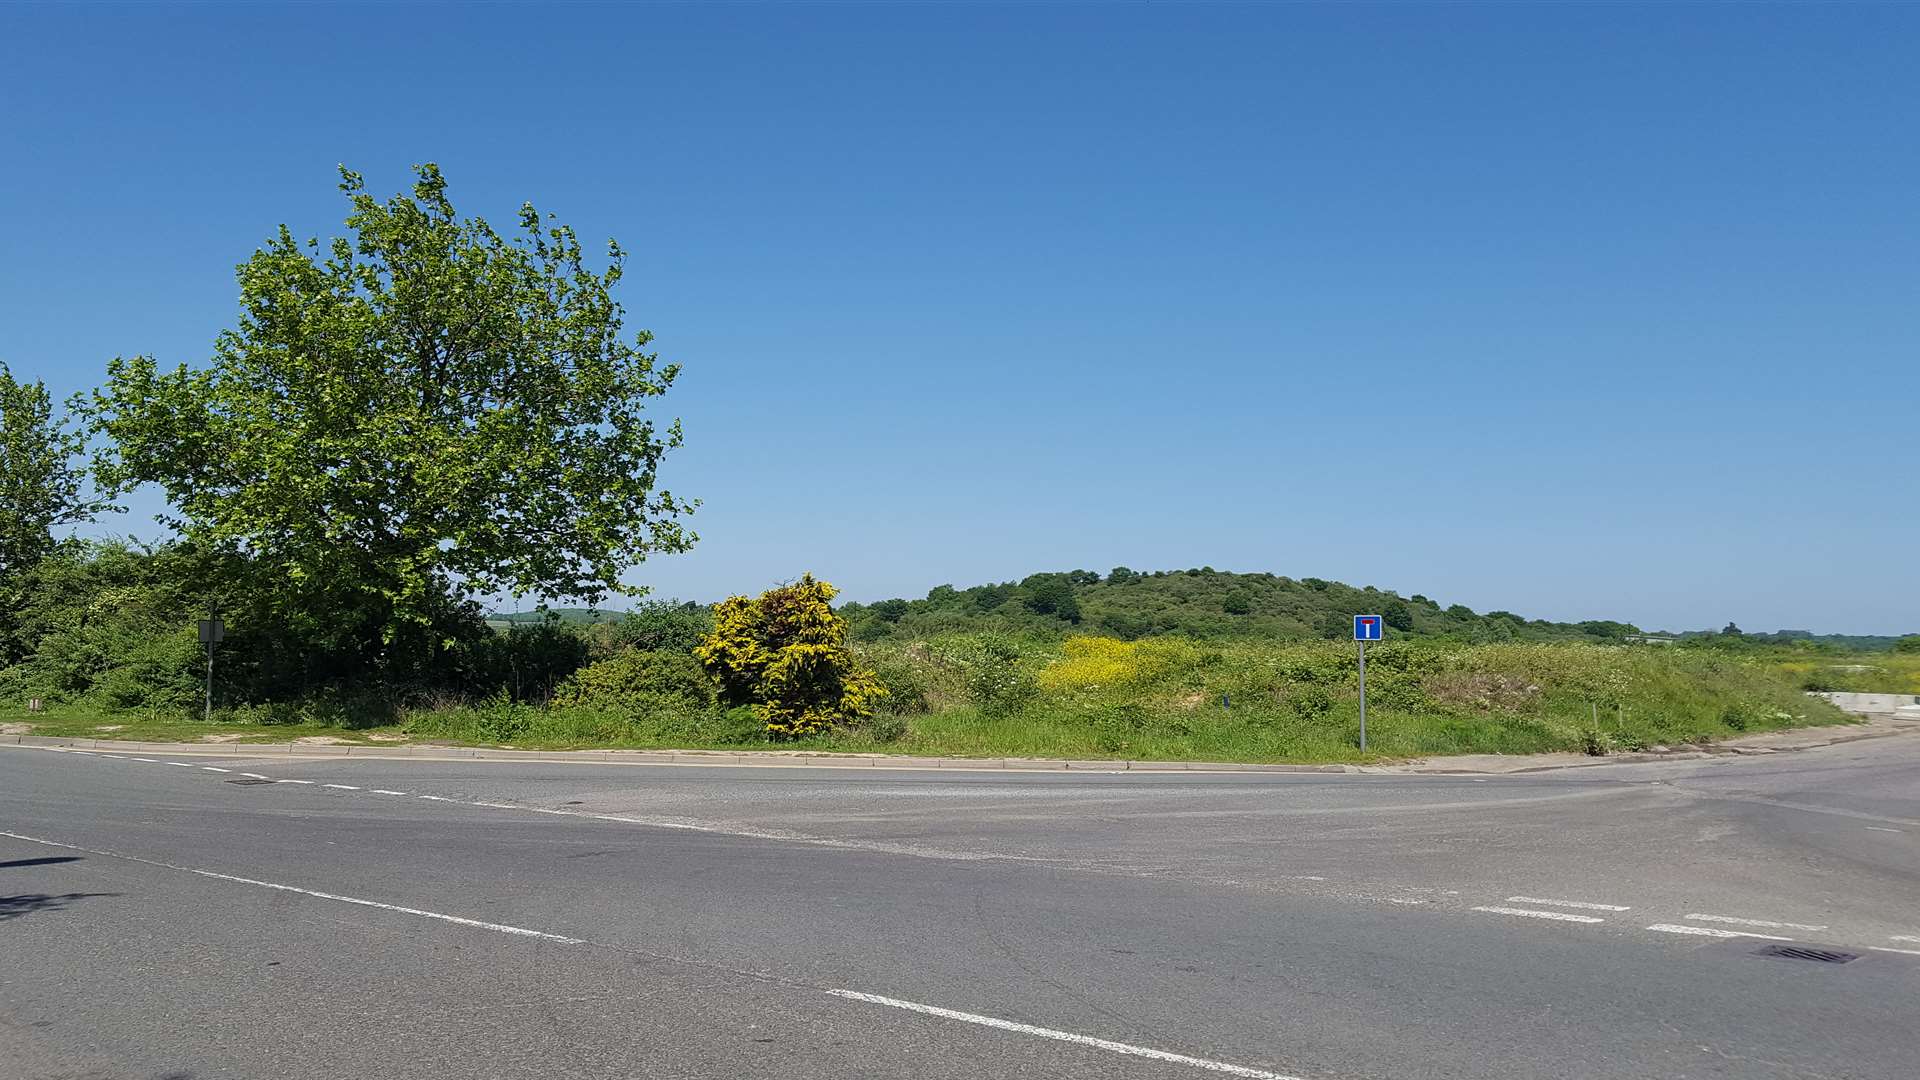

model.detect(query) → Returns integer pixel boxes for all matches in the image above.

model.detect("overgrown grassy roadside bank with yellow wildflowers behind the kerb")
[0,632,1851,763]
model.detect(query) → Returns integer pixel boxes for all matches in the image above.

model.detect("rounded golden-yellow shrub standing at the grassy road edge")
[693,575,887,738]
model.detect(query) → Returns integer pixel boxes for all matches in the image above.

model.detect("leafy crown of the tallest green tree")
[92,165,695,651]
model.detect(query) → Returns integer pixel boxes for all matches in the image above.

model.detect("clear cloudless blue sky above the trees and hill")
[0,4,1920,632]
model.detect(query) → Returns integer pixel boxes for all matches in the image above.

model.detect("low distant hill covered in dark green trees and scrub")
[841,567,1640,642]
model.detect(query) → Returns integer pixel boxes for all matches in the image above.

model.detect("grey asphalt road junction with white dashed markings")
[0,736,1920,1080]
